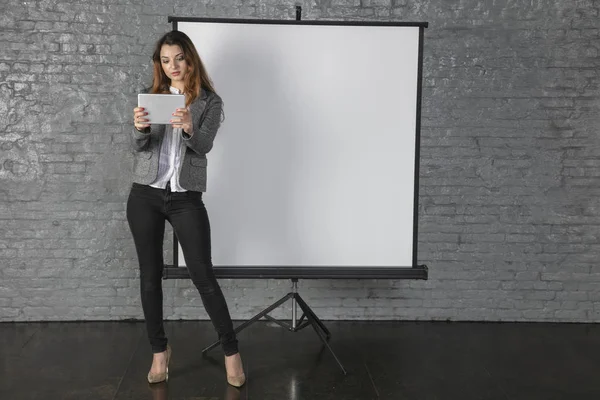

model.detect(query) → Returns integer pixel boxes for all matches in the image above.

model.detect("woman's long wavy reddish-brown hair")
[150,31,215,106]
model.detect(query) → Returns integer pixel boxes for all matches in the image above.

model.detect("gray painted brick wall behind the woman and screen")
[0,0,600,322]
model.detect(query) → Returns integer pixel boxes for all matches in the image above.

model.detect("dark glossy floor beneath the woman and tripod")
[0,321,600,400]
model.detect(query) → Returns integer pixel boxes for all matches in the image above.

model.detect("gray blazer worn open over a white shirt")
[132,88,223,192]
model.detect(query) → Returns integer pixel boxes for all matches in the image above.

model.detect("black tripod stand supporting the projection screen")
[202,278,347,375]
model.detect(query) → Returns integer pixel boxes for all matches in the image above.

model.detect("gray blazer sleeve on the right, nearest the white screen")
[182,95,223,155]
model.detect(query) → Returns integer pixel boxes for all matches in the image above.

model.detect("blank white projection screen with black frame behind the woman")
[165,17,426,279]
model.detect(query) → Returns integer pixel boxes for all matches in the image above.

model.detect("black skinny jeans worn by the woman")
[127,183,238,356]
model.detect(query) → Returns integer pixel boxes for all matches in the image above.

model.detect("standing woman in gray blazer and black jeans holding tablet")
[127,31,245,387]
